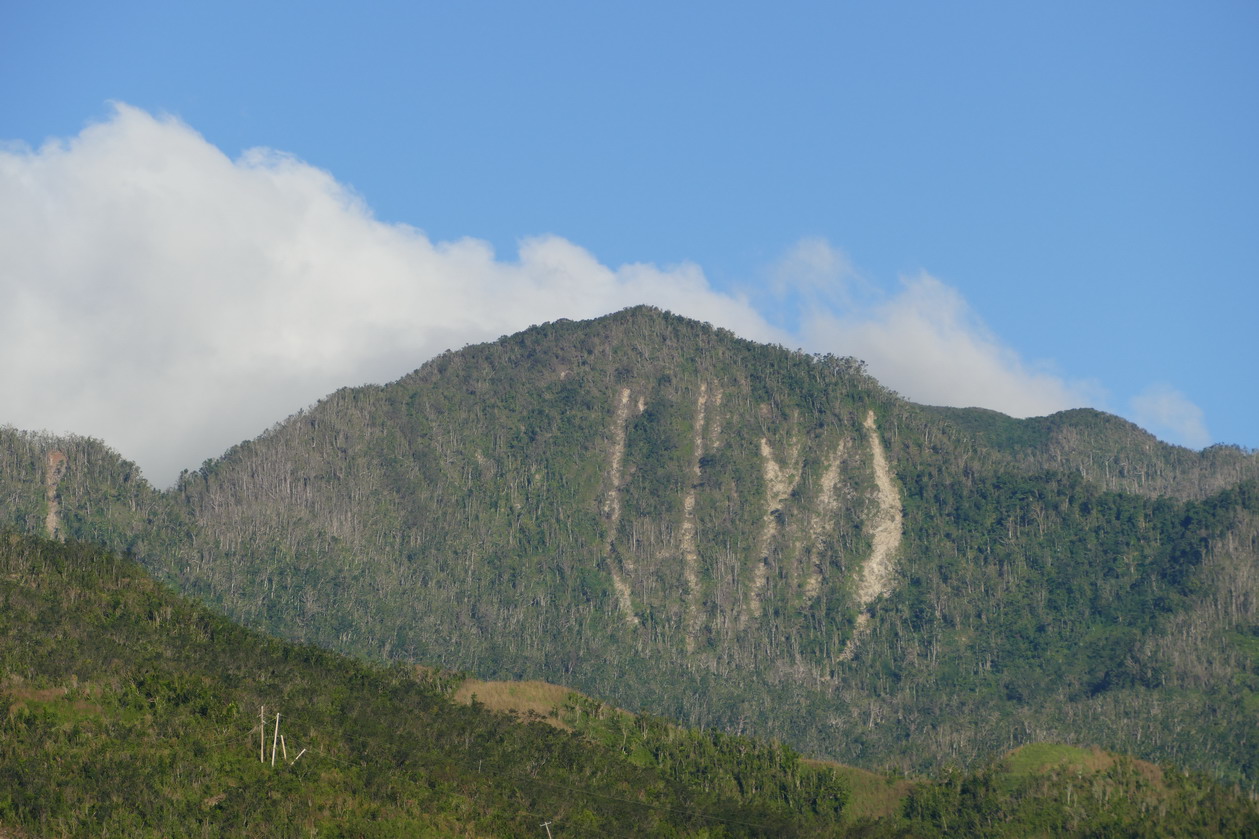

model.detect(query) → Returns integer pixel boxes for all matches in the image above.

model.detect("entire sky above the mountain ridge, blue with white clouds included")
[0,0,1259,484]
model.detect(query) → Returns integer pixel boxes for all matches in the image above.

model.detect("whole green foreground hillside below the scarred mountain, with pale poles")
[0,534,1259,838]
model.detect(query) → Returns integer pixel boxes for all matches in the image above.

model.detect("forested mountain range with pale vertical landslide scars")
[0,307,1259,787]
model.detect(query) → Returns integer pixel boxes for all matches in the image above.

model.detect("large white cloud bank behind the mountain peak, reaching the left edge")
[0,105,1158,486]
